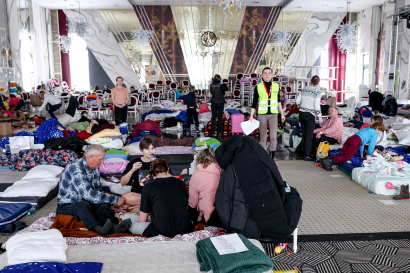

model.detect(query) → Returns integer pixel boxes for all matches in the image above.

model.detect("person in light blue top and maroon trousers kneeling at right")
[320,121,386,170]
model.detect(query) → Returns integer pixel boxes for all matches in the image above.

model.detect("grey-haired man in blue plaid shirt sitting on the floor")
[57,145,131,236]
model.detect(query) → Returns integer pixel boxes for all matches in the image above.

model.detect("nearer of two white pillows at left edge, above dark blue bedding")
[0,177,60,197]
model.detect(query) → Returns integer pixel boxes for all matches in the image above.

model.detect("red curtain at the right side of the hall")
[329,15,347,102]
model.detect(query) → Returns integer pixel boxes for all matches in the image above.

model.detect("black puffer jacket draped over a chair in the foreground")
[215,136,302,243]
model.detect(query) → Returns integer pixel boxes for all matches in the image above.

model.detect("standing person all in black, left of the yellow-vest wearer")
[209,74,225,138]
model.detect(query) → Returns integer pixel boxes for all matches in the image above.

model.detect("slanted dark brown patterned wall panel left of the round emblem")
[134,6,188,79]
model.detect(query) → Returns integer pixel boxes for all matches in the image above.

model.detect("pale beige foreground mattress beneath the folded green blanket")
[0,240,272,273]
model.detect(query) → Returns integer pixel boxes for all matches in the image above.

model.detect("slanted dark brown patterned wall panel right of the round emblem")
[230,7,281,74]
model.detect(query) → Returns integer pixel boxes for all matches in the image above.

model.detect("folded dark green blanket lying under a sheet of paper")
[196,234,273,273]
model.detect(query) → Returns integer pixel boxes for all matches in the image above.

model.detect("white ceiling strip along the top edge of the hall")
[31,0,384,12]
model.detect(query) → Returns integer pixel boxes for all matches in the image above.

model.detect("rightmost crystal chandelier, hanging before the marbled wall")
[335,1,357,54]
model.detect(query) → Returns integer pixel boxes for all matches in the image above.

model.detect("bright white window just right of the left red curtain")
[70,36,90,91]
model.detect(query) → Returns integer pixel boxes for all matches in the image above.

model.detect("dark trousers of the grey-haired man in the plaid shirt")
[57,201,118,230]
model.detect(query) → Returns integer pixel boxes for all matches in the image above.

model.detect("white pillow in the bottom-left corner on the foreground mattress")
[6,229,67,265]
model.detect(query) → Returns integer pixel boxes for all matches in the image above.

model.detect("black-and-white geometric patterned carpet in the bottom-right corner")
[262,240,410,273]
